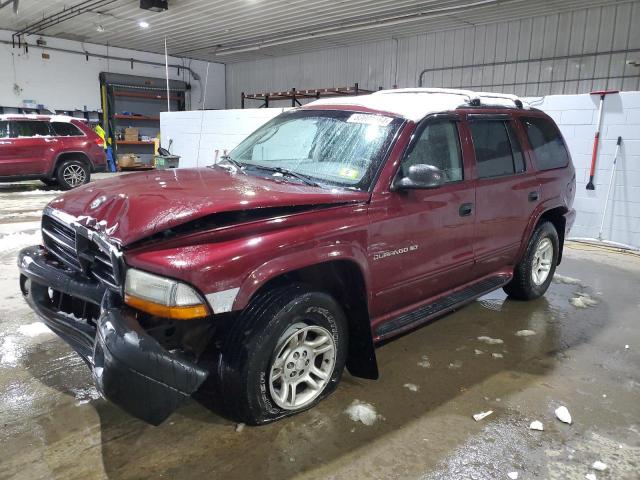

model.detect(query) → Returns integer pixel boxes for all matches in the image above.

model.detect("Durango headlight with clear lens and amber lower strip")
[124,268,209,320]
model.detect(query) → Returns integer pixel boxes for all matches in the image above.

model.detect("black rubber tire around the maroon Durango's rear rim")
[503,222,560,300]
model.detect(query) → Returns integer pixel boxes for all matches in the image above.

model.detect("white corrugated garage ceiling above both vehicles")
[0,0,629,63]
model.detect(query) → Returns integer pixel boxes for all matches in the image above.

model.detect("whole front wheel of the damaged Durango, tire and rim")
[219,284,347,425]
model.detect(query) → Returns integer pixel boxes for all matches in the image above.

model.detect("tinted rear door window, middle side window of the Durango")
[469,120,516,178]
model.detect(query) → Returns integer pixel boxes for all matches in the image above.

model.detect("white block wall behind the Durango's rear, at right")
[530,92,640,248]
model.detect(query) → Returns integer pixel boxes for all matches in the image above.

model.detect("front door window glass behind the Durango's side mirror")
[400,120,463,183]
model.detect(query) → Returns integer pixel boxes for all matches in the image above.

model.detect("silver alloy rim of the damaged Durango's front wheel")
[269,323,336,410]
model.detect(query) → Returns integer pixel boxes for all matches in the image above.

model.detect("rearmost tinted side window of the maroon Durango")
[522,117,569,170]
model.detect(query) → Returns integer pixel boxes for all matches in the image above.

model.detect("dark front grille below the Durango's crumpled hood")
[42,214,120,290]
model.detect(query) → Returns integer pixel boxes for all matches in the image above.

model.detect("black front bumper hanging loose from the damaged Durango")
[18,246,209,425]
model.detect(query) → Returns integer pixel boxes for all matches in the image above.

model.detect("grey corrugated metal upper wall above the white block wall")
[227,0,640,108]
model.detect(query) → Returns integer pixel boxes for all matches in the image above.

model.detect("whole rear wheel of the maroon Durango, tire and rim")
[504,222,560,300]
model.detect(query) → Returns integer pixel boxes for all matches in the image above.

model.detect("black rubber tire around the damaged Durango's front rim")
[218,284,348,425]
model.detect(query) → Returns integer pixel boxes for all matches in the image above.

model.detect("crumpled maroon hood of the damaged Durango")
[49,168,369,246]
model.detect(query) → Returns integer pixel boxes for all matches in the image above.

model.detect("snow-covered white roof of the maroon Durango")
[307,88,530,122]
